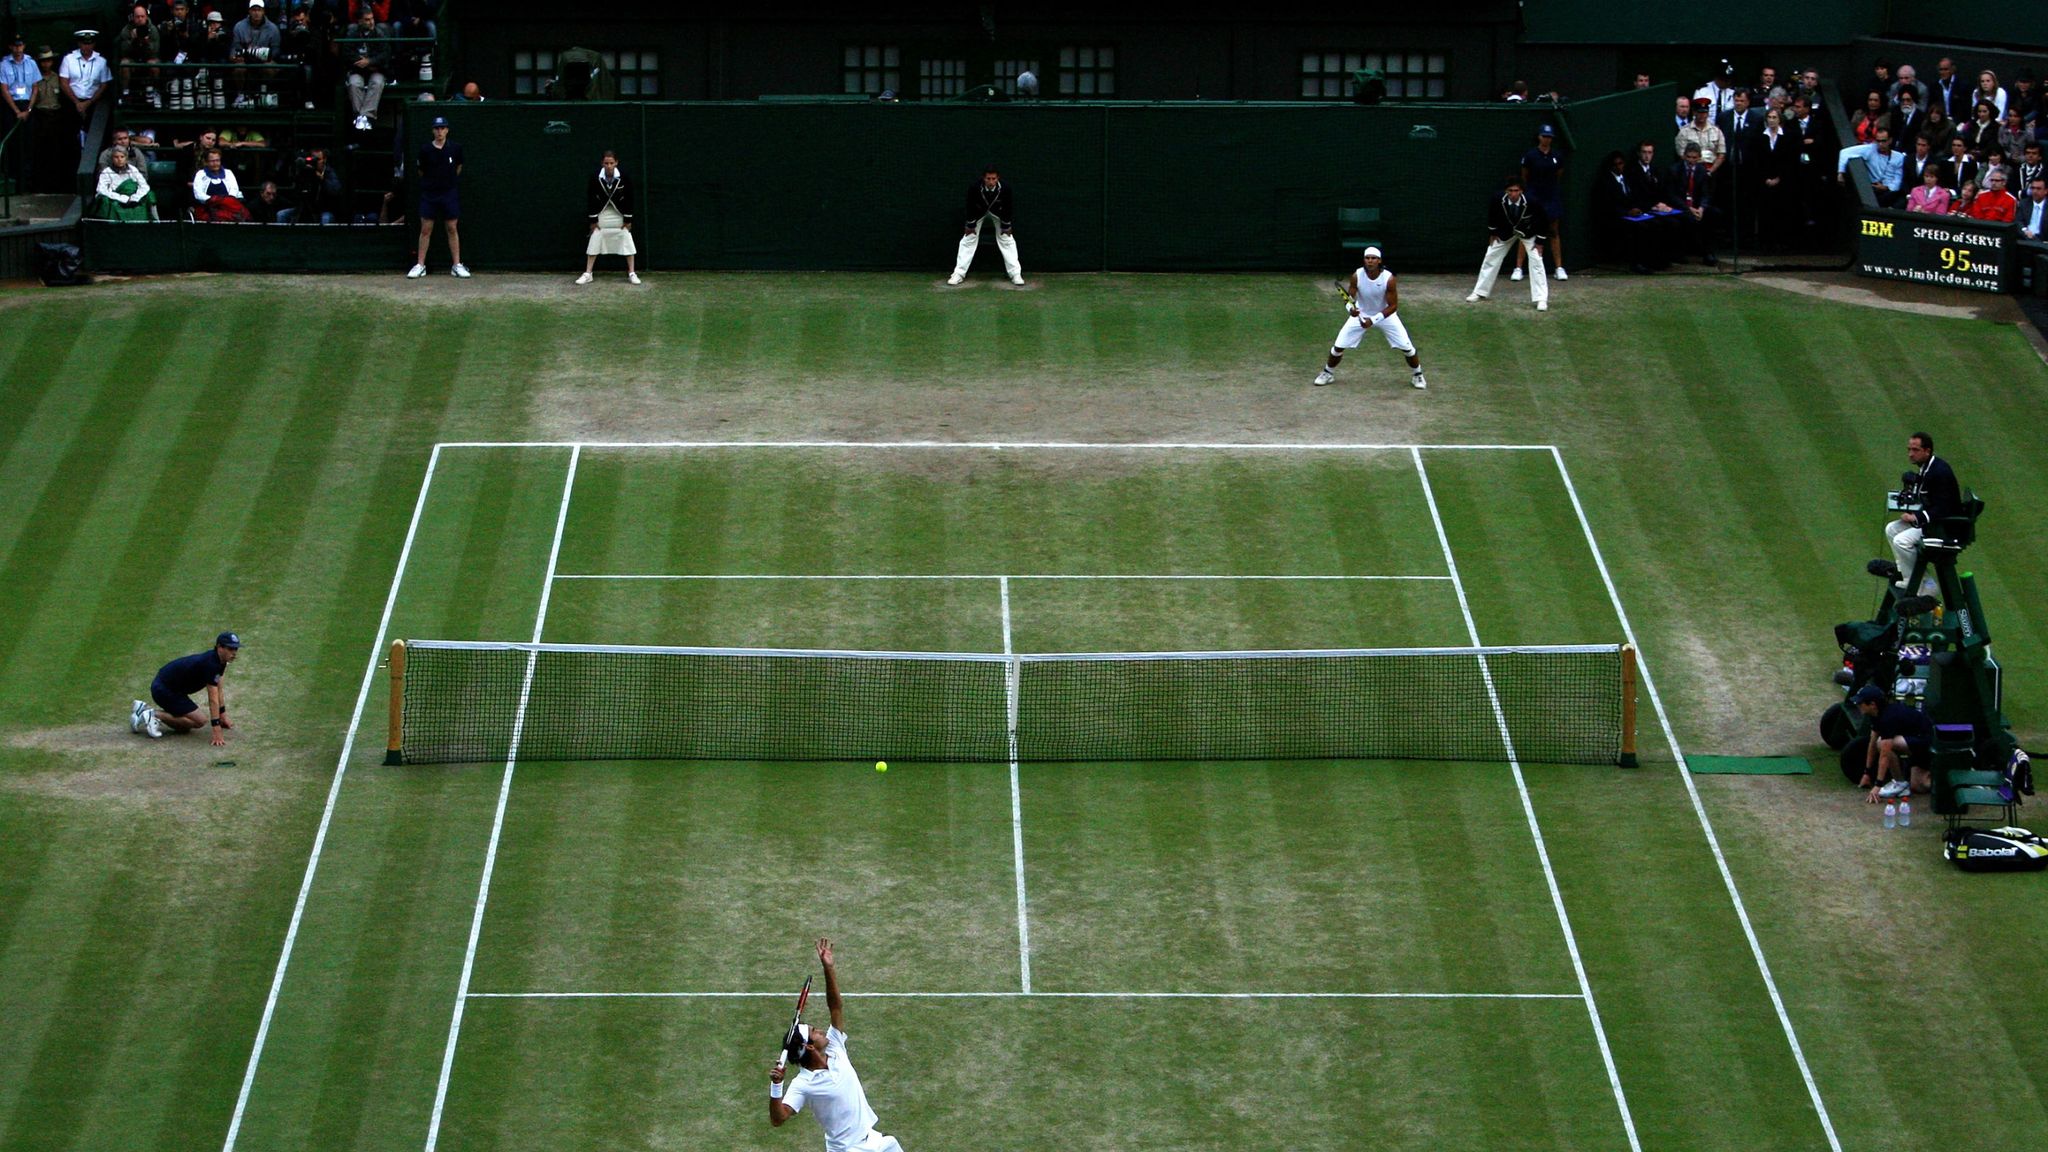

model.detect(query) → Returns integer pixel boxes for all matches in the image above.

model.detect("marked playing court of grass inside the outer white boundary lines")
[216,445,1831,1148]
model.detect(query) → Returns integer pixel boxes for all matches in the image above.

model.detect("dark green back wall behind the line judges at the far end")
[399,92,1669,273]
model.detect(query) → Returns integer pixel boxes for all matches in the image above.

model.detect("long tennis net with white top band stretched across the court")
[385,640,1634,765]
